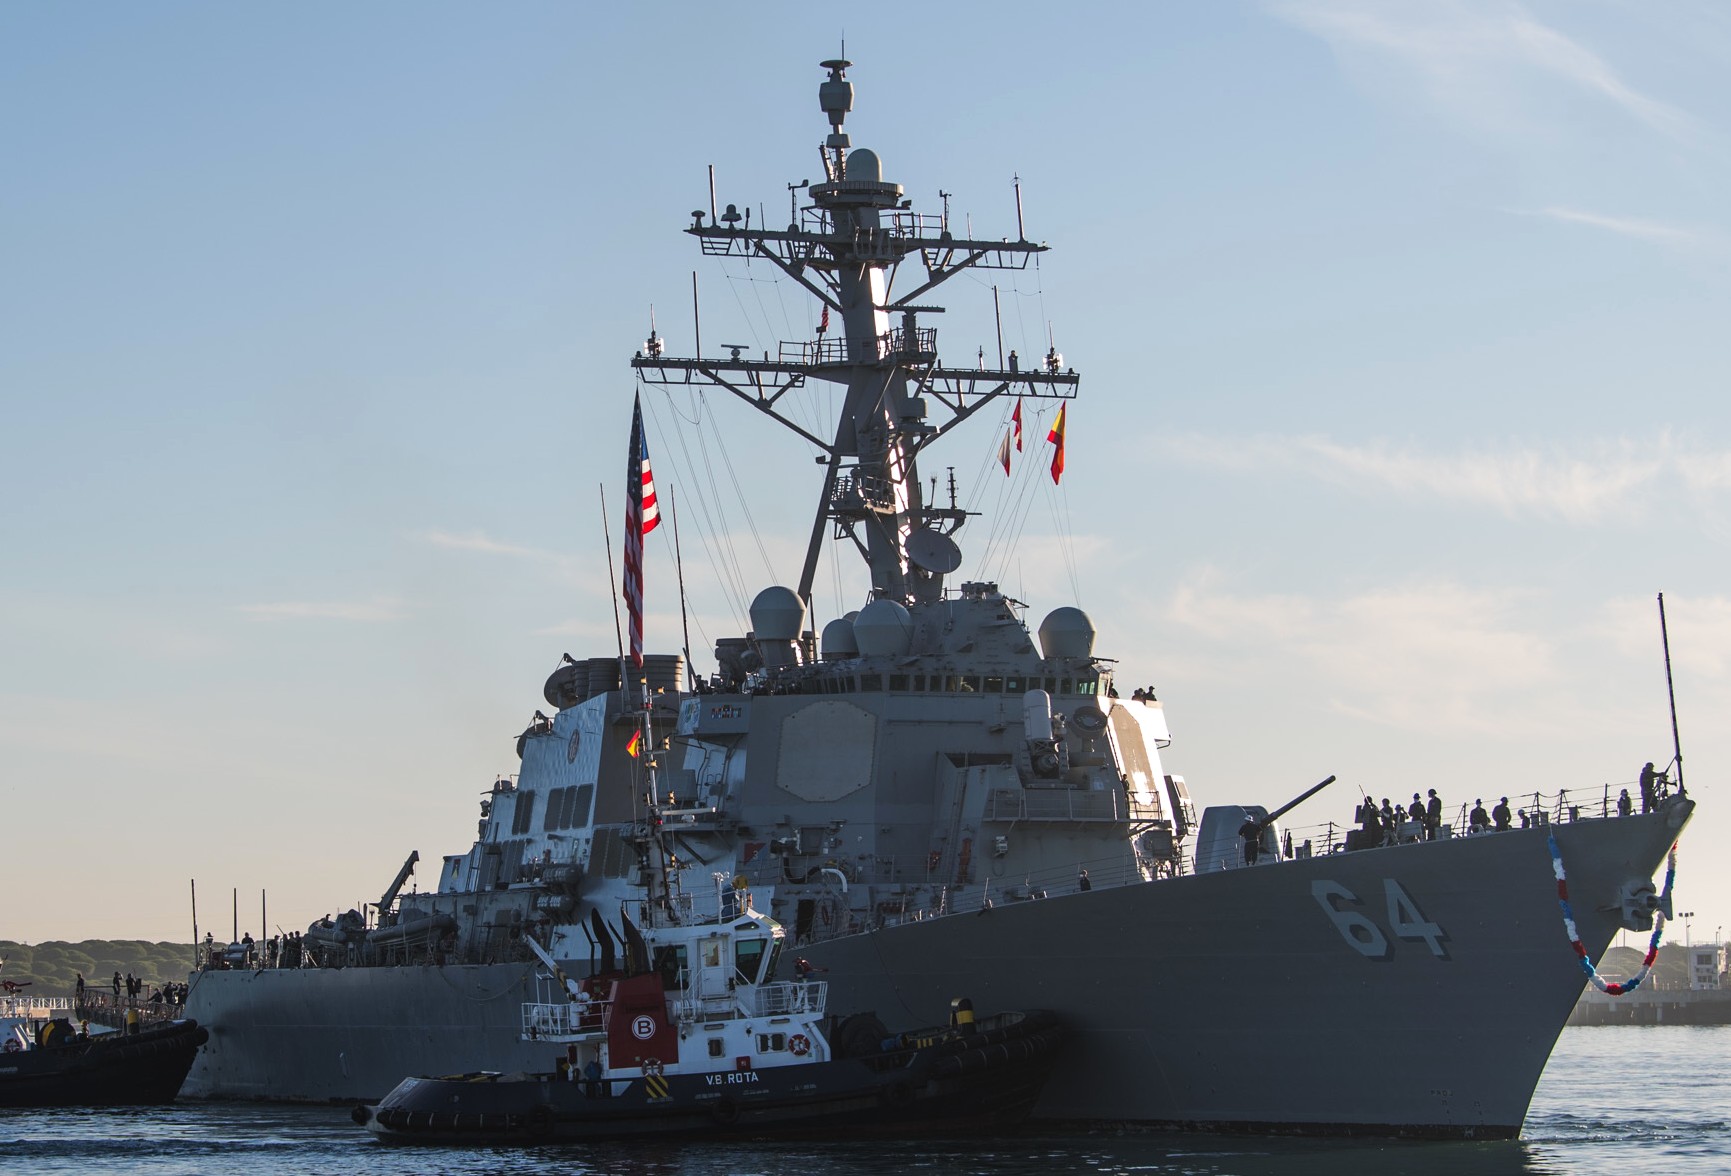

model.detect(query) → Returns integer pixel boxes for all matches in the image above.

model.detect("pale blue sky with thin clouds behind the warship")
[0,0,1731,940]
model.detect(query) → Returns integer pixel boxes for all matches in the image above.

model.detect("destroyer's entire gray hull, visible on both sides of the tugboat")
[185,802,1691,1138]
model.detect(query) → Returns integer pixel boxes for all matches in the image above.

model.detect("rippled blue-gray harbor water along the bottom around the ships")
[0,1025,1731,1176]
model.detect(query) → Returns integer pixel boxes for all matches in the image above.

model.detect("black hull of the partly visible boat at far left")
[0,1017,209,1107]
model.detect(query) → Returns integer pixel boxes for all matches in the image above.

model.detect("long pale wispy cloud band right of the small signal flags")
[1162,435,1731,523]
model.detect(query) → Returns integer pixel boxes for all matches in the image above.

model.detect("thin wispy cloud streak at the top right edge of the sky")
[1269,0,1693,139]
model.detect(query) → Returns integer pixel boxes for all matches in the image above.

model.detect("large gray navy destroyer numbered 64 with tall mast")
[187,61,1693,1138]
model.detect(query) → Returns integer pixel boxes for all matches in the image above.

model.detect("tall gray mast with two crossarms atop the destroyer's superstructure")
[632,61,1078,608]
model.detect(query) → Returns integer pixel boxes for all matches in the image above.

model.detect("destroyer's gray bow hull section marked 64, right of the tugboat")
[807,812,1681,1138]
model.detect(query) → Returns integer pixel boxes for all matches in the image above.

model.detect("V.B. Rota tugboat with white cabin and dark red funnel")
[353,789,1063,1143]
